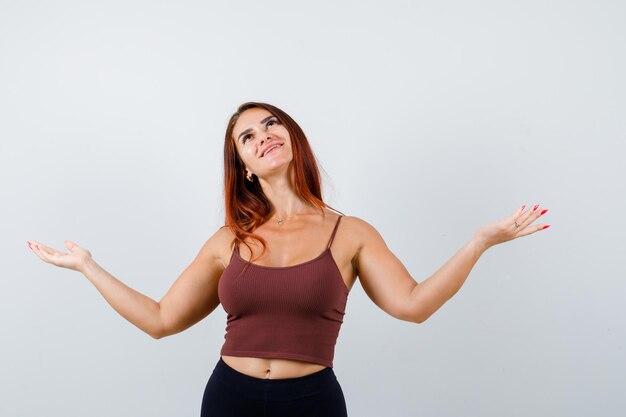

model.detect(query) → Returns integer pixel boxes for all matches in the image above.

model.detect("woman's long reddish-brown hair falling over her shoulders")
[224,101,343,267]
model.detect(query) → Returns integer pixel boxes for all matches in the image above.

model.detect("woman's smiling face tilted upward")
[233,107,293,178]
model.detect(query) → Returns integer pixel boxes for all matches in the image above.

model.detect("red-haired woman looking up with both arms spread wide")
[28,102,548,417]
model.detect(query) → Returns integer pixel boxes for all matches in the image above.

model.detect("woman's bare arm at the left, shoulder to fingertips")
[33,228,229,339]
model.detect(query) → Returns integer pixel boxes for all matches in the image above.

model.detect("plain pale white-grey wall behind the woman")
[0,0,626,417]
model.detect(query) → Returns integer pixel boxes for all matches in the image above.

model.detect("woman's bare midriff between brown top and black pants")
[222,355,326,379]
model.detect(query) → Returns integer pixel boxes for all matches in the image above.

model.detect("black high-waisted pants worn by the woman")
[201,356,348,417]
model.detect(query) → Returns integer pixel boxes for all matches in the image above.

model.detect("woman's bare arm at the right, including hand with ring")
[356,205,548,323]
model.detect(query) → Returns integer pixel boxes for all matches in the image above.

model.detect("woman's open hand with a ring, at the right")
[474,204,550,249]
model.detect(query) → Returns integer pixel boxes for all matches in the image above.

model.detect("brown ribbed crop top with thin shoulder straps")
[218,216,349,368]
